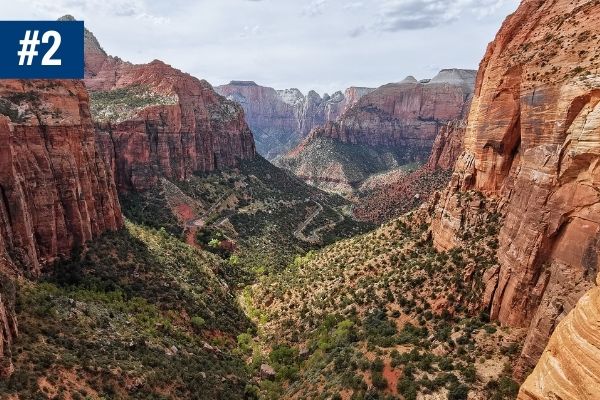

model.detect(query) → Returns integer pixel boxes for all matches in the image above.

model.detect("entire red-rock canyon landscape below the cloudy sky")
[0,0,600,400]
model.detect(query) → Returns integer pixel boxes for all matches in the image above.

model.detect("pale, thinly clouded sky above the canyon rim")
[0,0,519,94]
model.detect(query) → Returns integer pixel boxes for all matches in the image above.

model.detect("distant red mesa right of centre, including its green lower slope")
[277,69,475,194]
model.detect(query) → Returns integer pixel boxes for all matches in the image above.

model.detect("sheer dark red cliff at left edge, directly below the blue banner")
[0,80,123,375]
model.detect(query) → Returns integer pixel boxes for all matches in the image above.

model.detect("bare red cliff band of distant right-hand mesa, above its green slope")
[308,70,475,150]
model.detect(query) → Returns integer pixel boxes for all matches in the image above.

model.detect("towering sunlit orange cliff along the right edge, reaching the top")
[432,0,600,376]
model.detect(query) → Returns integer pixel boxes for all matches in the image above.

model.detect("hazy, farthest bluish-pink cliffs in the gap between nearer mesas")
[215,81,374,159]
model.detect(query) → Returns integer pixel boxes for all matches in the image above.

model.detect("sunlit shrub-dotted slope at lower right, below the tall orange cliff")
[242,193,520,399]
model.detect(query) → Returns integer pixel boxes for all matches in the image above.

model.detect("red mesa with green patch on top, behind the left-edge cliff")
[85,34,255,191]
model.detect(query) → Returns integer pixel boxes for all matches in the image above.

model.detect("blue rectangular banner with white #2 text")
[0,21,84,79]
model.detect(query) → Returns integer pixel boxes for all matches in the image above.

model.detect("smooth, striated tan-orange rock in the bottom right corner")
[518,275,600,400]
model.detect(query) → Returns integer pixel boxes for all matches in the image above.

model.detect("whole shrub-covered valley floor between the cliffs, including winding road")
[0,168,522,400]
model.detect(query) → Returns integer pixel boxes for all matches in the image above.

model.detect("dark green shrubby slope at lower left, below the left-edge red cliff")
[0,223,254,399]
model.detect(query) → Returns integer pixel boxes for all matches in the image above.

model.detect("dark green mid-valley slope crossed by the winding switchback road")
[121,157,373,272]
